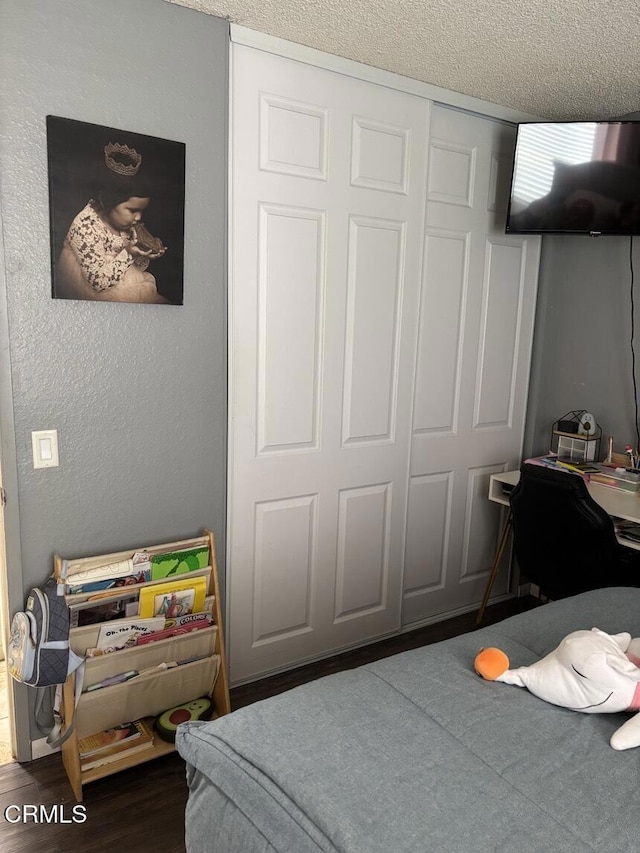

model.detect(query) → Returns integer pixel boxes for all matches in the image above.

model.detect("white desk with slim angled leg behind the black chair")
[476,470,640,625]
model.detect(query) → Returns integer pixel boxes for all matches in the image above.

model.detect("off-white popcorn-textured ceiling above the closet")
[168,0,640,119]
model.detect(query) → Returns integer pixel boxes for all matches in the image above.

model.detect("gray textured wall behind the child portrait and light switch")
[0,0,228,757]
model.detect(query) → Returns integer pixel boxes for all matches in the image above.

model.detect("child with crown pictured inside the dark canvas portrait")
[55,142,167,303]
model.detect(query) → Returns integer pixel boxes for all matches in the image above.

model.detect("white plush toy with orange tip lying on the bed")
[474,628,640,749]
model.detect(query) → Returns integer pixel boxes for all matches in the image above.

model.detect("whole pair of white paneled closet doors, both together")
[227,45,537,683]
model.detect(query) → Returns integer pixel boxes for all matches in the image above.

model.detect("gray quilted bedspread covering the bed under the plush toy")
[176,589,640,853]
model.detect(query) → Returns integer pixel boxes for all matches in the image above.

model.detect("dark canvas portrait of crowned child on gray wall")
[47,116,185,305]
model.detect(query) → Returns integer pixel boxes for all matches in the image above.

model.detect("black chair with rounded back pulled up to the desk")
[509,463,640,599]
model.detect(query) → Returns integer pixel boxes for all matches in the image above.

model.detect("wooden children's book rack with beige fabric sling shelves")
[54,531,231,801]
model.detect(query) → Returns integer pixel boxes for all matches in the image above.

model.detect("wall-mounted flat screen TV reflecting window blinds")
[506,121,640,236]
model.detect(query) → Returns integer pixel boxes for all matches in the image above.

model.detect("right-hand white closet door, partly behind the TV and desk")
[402,105,540,626]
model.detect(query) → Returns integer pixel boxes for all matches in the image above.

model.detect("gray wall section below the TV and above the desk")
[525,235,640,456]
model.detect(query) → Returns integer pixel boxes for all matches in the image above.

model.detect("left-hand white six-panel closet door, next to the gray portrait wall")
[227,46,429,682]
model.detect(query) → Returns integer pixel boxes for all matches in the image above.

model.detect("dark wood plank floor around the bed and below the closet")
[0,598,539,853]
